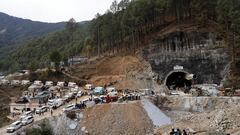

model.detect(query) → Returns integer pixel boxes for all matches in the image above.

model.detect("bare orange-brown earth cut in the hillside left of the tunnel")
[68,55,155,90]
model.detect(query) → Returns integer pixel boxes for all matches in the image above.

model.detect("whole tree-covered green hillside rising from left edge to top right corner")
[1,0,240,76]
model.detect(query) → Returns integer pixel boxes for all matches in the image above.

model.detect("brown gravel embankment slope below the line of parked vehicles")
[81,102,153,135]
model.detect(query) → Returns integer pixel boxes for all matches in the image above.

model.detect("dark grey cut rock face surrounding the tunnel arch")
[143,32,228,84]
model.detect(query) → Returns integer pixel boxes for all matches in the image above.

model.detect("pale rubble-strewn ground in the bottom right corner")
[156,105,240,135]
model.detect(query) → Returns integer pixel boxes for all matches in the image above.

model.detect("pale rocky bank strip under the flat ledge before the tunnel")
[156,96,240,112]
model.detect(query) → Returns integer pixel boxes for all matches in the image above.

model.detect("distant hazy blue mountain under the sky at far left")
[0,12,65,47]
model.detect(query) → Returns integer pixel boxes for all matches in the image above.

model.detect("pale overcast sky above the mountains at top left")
[0,0,113,22]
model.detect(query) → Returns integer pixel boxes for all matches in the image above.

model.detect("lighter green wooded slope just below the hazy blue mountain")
[0,20,89,72]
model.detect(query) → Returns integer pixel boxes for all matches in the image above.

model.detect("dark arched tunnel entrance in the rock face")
[165,71,192,91]
